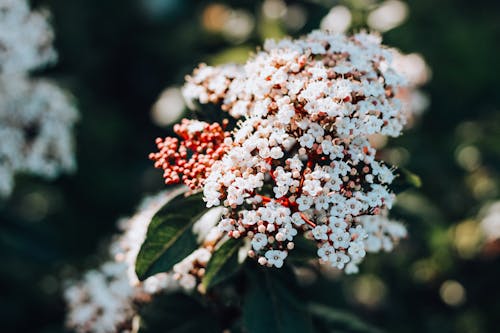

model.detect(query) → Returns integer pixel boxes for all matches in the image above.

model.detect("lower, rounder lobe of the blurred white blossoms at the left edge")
[0,77,78,196]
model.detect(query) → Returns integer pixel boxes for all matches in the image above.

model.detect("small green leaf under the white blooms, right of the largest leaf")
[202,238,243,290]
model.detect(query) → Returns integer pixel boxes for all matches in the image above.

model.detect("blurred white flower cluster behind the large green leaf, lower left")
[64,188,221,333]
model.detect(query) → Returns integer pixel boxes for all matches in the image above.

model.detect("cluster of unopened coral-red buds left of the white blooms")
[149,119,230,190]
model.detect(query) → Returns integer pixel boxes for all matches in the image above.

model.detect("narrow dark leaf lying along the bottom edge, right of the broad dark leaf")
[308,303,382,333]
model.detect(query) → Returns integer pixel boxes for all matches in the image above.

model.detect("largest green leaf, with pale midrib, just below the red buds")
[135,193,208,281]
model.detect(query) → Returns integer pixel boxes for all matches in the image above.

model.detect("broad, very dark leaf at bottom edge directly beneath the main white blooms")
[243,269,312,333]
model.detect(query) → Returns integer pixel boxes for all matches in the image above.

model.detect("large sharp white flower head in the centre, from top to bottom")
[184,31,406,272]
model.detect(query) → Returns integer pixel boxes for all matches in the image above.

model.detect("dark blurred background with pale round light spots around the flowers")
[0,0,500,333]
